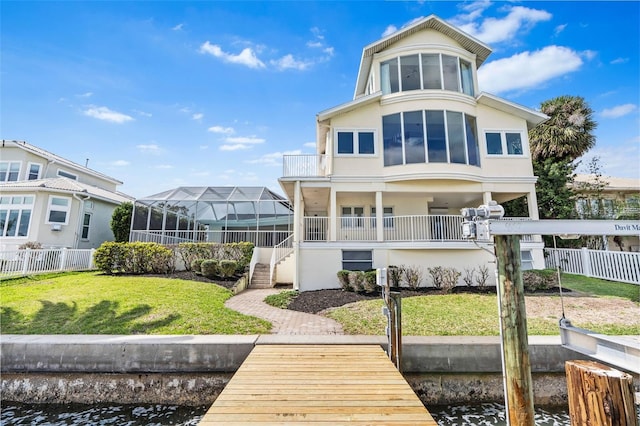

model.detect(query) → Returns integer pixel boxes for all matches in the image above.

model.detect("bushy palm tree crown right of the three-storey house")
[529,96,597,161]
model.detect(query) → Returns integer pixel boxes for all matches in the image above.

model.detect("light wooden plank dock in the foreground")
[199,345,437,426]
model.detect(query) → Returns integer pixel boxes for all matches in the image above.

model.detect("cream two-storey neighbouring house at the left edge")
[0,140,133,250]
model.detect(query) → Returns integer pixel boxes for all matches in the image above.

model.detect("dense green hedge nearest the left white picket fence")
[93,241,174,274]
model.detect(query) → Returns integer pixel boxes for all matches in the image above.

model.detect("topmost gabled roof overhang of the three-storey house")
[354,15,491,98]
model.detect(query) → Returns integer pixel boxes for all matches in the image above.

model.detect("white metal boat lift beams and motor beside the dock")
[461,205,640,374]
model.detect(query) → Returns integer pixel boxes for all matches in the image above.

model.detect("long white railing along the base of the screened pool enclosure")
[129,230,291,247]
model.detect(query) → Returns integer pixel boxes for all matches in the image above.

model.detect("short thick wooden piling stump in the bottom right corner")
[565,360,638,426]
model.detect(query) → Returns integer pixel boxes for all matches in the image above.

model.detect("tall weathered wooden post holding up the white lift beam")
[494,235,535,426]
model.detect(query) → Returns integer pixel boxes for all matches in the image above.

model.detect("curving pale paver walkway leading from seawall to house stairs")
[224,288,344,335]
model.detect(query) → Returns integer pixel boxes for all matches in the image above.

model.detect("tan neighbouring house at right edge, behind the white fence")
[573,174,640,252]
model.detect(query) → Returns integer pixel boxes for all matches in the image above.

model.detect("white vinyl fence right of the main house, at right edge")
[544,248,640,285]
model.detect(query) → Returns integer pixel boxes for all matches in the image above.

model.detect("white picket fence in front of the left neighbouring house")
[0,248,95,278]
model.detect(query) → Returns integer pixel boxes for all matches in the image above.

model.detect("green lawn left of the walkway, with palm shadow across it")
[0,272,271,334]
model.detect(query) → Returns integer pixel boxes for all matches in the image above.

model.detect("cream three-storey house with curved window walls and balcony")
[279,15,547,291]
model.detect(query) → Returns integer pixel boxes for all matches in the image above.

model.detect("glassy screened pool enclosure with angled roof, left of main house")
[130,186,293,247]
